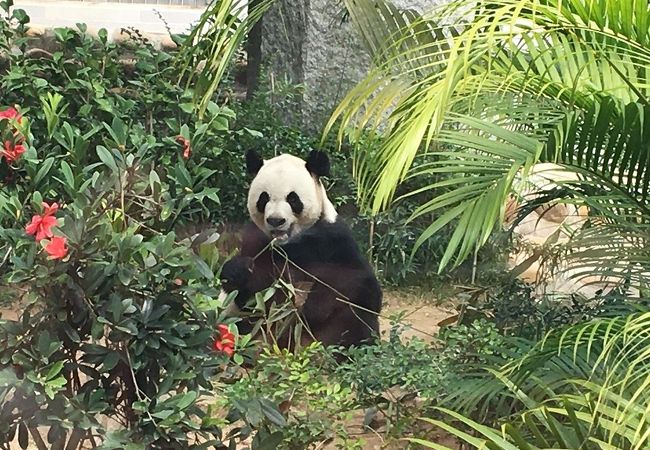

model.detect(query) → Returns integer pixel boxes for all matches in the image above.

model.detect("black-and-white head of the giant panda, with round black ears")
[246,151,336,244]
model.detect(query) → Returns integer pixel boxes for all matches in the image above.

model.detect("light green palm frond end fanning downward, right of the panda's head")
[402,116,541,268]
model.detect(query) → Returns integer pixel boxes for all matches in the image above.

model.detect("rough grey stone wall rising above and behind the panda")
[262,0,444,131]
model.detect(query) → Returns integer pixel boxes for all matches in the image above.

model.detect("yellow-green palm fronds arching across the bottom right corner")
[424,311,650,450]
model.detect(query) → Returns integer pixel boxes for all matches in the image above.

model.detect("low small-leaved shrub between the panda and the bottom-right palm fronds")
[332,321,520,438]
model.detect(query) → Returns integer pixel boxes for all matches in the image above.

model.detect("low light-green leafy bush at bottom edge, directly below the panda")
[218,343,360,449]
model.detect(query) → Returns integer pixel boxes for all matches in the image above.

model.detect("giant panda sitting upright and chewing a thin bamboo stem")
[221,151,382,347]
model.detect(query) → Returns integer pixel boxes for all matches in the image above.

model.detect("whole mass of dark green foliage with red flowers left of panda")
[0,6,264,449]
